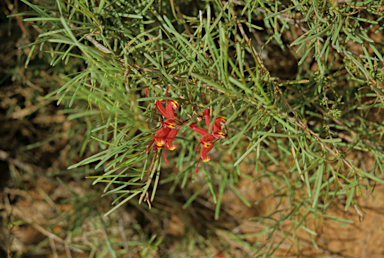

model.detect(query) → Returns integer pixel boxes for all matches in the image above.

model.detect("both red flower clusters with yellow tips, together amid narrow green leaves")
[144,87,227,173]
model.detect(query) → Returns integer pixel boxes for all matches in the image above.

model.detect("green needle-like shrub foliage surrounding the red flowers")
[16,0,384,256]
